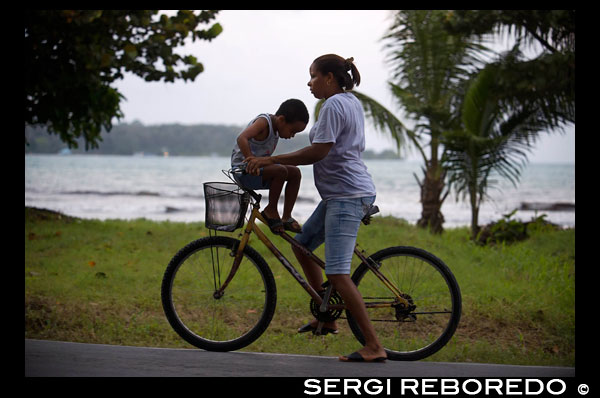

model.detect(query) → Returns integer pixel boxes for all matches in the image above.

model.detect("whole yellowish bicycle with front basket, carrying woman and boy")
[161,169,462,360]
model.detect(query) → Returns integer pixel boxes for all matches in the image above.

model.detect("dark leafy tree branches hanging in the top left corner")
[23,10,222,149]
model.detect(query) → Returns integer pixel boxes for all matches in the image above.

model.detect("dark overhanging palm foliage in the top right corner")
[445,10,575,128]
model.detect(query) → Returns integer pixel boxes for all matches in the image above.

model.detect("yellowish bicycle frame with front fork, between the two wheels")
[215,200,409,310]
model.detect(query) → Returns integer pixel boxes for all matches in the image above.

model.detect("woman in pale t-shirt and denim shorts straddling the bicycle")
[247,54,387,362]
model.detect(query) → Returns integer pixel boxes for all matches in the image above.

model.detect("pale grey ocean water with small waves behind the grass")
[25,154,575,228]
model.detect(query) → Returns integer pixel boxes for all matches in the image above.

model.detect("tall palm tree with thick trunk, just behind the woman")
[355,10,486,233]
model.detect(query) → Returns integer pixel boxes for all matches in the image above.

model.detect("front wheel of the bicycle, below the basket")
[161,236,277,351]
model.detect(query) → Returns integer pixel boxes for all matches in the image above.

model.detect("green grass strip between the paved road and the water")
[25,208,575,366]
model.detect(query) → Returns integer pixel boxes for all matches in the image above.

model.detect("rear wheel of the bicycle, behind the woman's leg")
[347,246,462,361]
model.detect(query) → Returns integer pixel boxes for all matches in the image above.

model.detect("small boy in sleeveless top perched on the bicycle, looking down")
[231,99,308,233]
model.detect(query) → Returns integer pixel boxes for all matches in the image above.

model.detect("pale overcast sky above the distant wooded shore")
[110,10,575,163]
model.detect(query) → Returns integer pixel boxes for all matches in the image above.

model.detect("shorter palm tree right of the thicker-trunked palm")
[443,64,547,239]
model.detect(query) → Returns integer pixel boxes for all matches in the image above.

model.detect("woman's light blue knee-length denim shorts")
[294,196,375,275]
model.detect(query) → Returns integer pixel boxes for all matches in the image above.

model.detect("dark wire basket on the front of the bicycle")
[204,182,250,232]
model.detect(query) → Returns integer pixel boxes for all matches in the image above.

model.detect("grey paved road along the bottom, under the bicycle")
[25,339,575,378]
